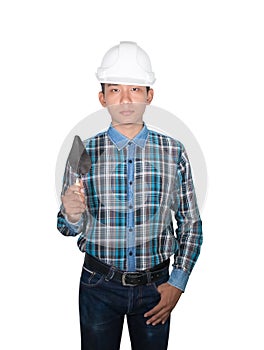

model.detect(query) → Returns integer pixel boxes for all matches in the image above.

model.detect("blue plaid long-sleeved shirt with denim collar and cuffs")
[58,125,202,290]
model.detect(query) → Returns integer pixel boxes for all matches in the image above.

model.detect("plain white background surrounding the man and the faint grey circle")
[0,0,264,350]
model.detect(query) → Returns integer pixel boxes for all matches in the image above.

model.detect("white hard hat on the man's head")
[96,41,156,86]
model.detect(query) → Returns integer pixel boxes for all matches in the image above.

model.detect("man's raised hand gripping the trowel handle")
[61,182,86,223]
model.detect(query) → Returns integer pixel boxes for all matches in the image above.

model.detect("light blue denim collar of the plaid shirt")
[107,123,149,150]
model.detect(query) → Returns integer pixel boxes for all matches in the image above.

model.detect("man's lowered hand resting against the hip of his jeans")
[144,283,182,326]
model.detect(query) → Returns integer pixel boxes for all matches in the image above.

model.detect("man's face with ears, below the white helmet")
[99,84,153,125]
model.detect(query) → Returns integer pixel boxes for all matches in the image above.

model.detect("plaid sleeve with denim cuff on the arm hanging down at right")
[168,146,203,291]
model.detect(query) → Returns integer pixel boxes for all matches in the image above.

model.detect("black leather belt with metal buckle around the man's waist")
[84,253,170,286]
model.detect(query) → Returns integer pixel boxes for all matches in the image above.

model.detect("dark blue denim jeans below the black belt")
[79,267,170,350]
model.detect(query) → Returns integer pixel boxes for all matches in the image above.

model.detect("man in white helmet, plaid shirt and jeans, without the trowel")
[58,42,202,350]
